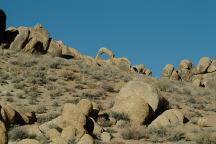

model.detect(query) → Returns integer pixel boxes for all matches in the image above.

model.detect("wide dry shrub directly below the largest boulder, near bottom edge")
[120,127,147,140]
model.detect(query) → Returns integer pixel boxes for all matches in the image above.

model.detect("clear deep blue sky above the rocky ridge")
[0,0,216,76]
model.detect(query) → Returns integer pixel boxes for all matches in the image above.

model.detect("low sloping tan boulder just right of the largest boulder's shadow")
[149,109,185,128]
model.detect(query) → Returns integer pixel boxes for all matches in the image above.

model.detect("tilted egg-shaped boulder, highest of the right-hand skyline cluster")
[197,57,211,74]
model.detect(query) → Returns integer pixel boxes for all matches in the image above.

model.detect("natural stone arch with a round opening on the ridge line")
[95,48,115,65]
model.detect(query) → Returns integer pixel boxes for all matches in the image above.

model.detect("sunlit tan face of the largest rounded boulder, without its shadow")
[113,81,165,125]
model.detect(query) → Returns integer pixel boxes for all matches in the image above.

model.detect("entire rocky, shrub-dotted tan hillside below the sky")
[0,10,216,144]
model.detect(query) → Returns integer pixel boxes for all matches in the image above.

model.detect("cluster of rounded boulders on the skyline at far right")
[161,57,216,87]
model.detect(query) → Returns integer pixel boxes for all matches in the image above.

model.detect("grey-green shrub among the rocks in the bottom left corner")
[8,127,37,141]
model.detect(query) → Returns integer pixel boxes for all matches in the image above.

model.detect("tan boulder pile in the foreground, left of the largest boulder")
[36,99,111,144]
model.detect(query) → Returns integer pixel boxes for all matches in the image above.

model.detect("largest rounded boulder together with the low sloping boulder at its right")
[112,81,185,127]
